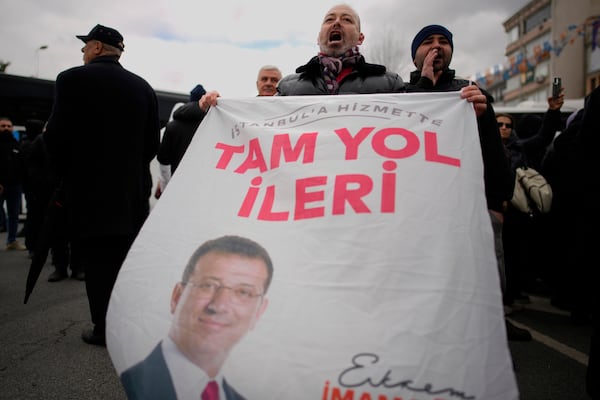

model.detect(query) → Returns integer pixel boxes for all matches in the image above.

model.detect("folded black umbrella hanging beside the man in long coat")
[23,185,65,304]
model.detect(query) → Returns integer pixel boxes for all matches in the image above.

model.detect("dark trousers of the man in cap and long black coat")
[71,235,135,335]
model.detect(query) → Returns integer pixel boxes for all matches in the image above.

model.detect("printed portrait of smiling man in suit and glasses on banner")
[121,235,273,400]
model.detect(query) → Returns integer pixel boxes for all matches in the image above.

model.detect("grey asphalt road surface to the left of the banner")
[0,233,126,400]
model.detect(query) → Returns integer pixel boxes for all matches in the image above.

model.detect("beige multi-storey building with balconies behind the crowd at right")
[486,0,600,106]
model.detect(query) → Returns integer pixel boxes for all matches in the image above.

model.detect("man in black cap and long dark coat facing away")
[44,25,160,346]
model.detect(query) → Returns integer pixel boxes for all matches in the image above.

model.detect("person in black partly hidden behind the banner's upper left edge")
[154,84,206,199]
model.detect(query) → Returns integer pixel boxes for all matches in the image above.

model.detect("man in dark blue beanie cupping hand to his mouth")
[410,25,531,340]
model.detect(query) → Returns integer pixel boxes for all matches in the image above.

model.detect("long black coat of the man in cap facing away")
[44,56,160,237]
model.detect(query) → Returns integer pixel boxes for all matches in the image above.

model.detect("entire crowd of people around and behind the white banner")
[0,4,600,393]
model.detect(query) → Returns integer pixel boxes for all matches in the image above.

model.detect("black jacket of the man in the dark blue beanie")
[408,69,515,212]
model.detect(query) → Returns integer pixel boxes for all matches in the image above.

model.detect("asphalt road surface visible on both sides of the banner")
[0,228,591,400]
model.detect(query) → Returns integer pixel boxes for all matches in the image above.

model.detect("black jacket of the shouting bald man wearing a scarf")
[277,56,405,96]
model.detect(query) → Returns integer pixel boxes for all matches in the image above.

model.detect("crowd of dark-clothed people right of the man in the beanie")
[496,87,600,398]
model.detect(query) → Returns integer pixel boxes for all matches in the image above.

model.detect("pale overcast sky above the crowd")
[0,0,529,97]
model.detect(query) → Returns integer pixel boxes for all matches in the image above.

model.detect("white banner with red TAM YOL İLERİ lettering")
[107,92,518,400]
